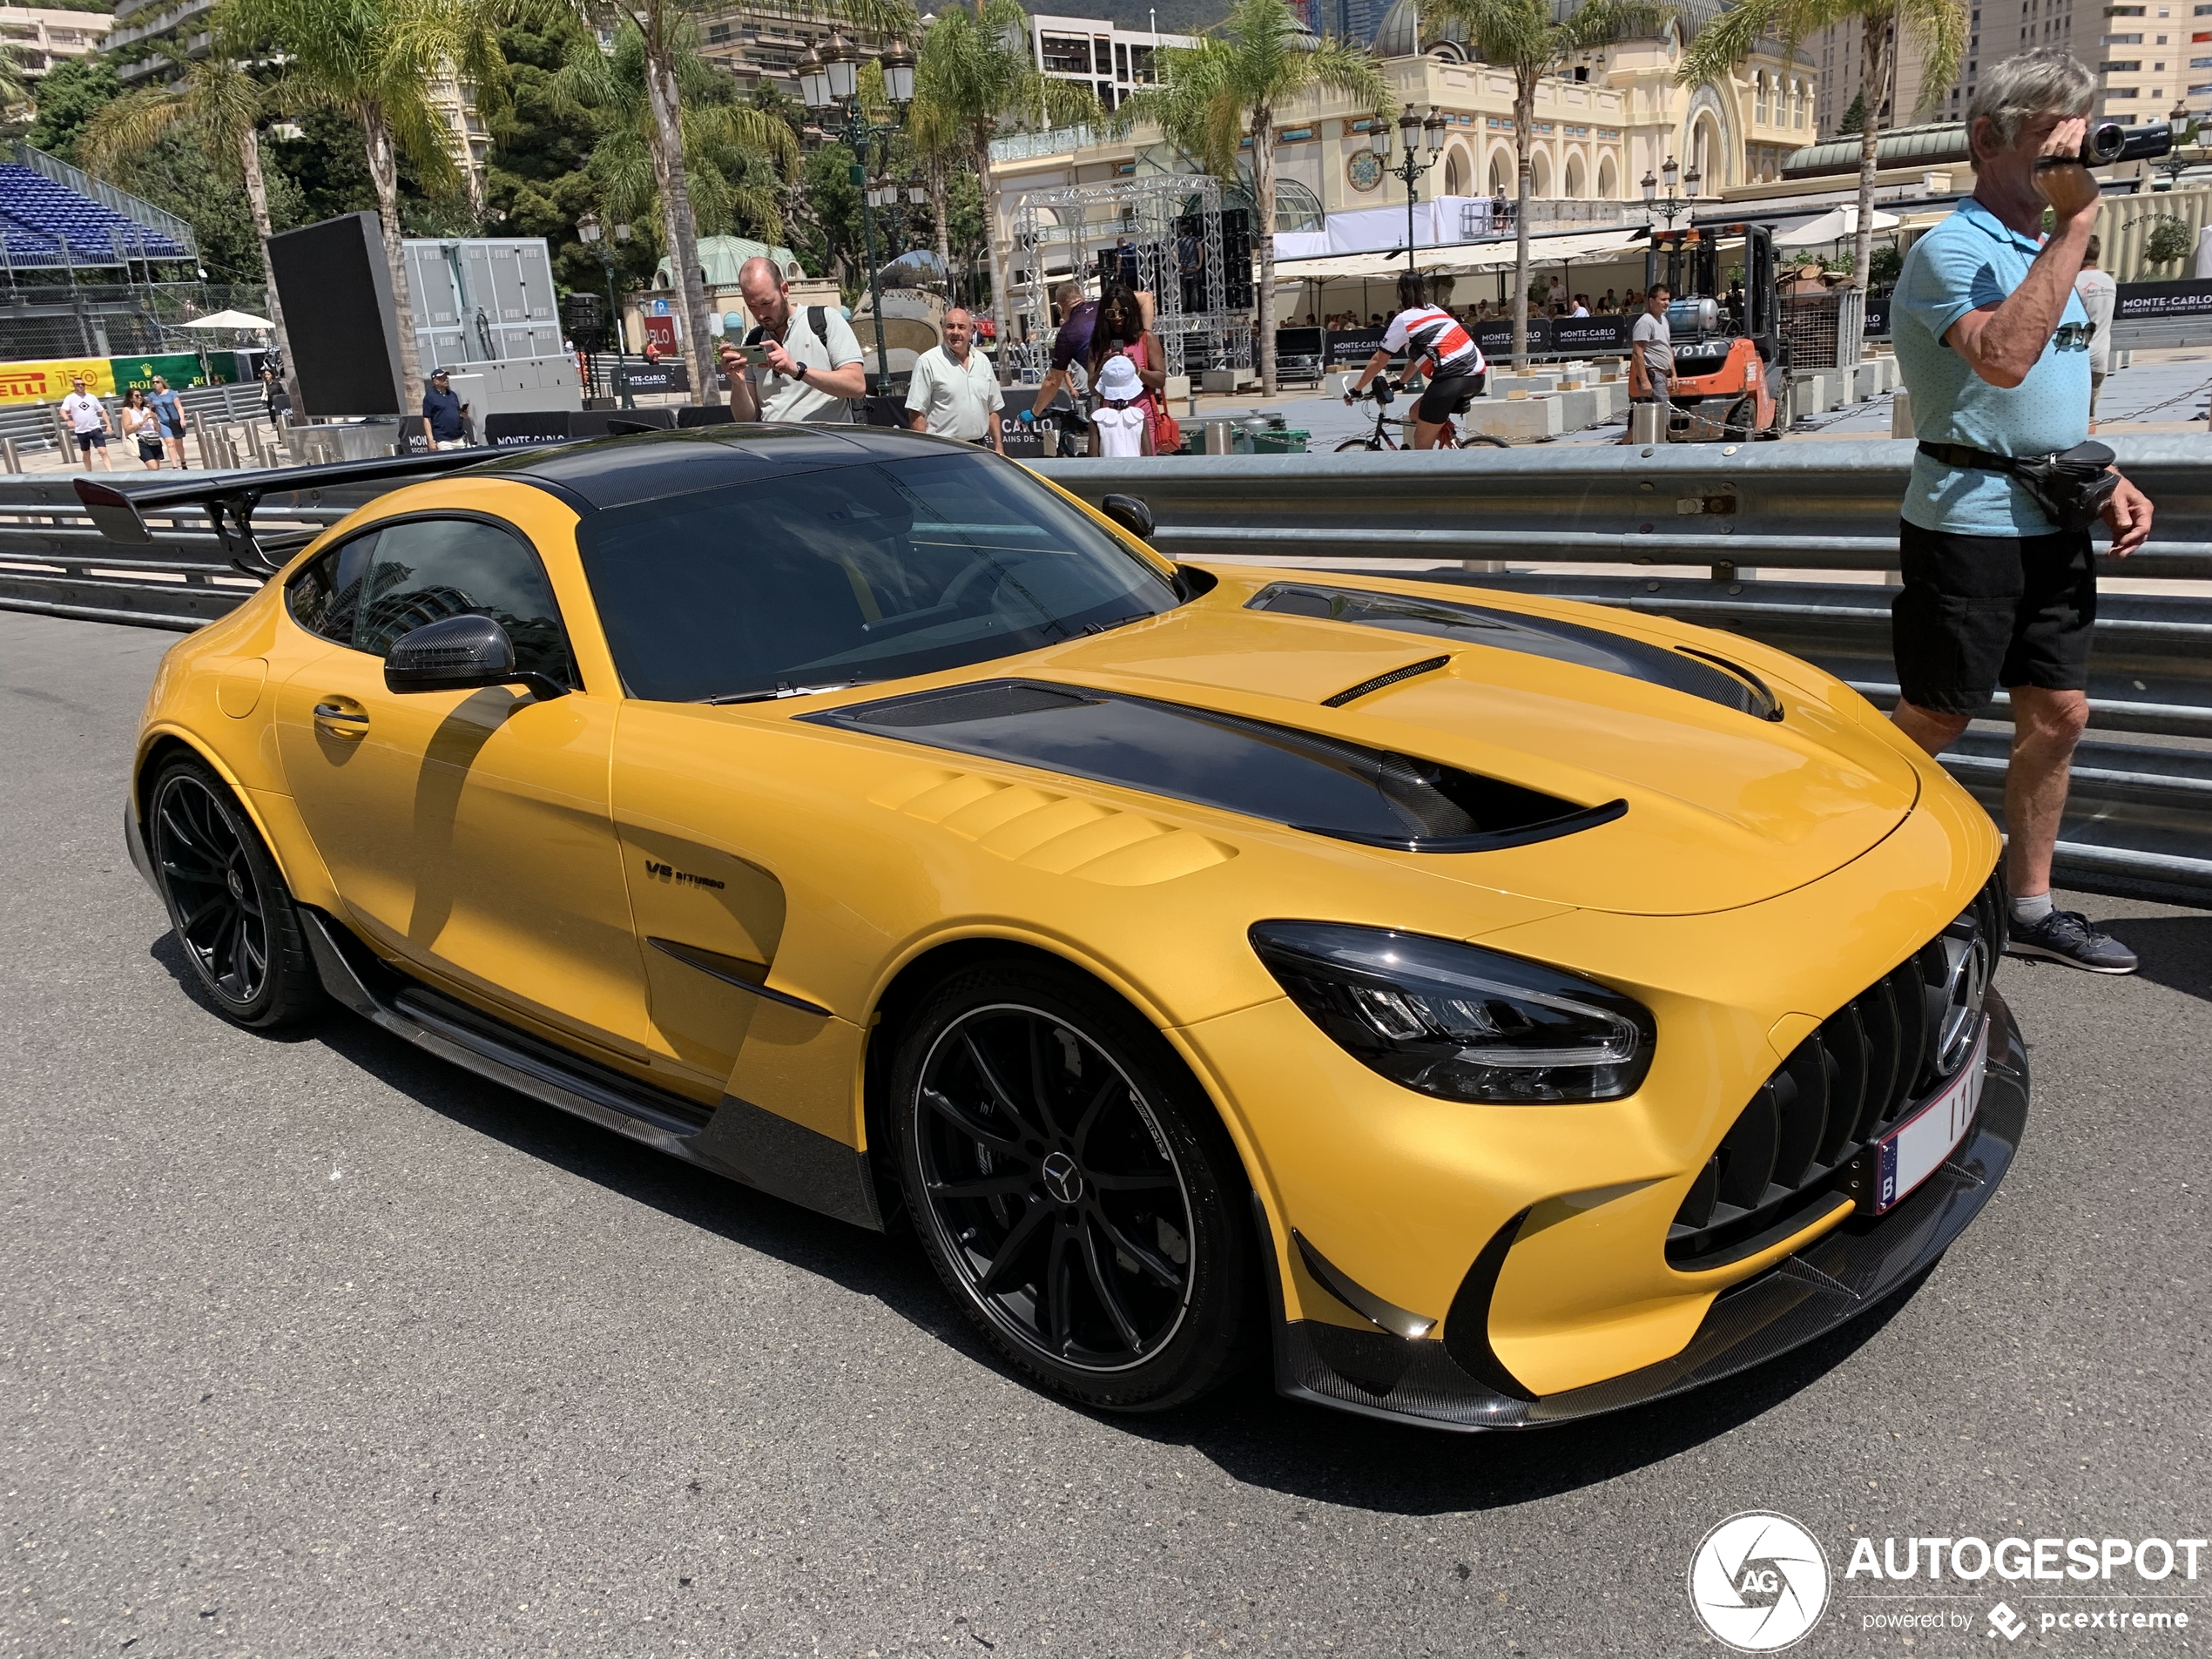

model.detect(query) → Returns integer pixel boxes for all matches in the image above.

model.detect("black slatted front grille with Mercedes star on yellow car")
[1666,873,2008,1272]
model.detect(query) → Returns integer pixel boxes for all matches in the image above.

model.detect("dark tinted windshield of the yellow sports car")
[577,454,1179,701]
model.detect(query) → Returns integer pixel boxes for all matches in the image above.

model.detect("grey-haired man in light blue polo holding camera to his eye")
[1892,49,2150,974]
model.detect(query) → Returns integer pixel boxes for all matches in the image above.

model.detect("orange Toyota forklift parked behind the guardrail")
[1628,224,1787,442]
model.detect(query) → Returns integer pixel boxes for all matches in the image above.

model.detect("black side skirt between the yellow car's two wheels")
[299,905,882,1232]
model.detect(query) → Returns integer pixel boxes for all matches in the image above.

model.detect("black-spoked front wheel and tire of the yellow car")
[889,960,1258,1412]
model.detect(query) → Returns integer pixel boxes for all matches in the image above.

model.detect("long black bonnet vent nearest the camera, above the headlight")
[800,679,1628,852]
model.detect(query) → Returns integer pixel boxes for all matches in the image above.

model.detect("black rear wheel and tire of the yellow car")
[146,759,323,1031]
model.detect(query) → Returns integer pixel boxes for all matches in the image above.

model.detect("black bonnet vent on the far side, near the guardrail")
[1245,582,1783,721]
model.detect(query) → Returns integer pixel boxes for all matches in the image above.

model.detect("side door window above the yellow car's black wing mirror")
[354,517,575,685]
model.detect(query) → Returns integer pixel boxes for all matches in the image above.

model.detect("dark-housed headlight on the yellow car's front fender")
[1252,922,1656,1103]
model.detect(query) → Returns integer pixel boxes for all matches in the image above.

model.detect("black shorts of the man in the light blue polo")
[1889,522,2097,714]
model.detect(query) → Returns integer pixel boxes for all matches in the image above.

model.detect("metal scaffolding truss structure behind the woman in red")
[1004,172,1252,374]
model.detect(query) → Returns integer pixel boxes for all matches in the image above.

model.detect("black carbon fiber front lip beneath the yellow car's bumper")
[1267,991,2028,1433]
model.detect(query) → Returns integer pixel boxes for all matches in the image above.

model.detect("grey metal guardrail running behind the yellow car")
[0,435,2212,902]
